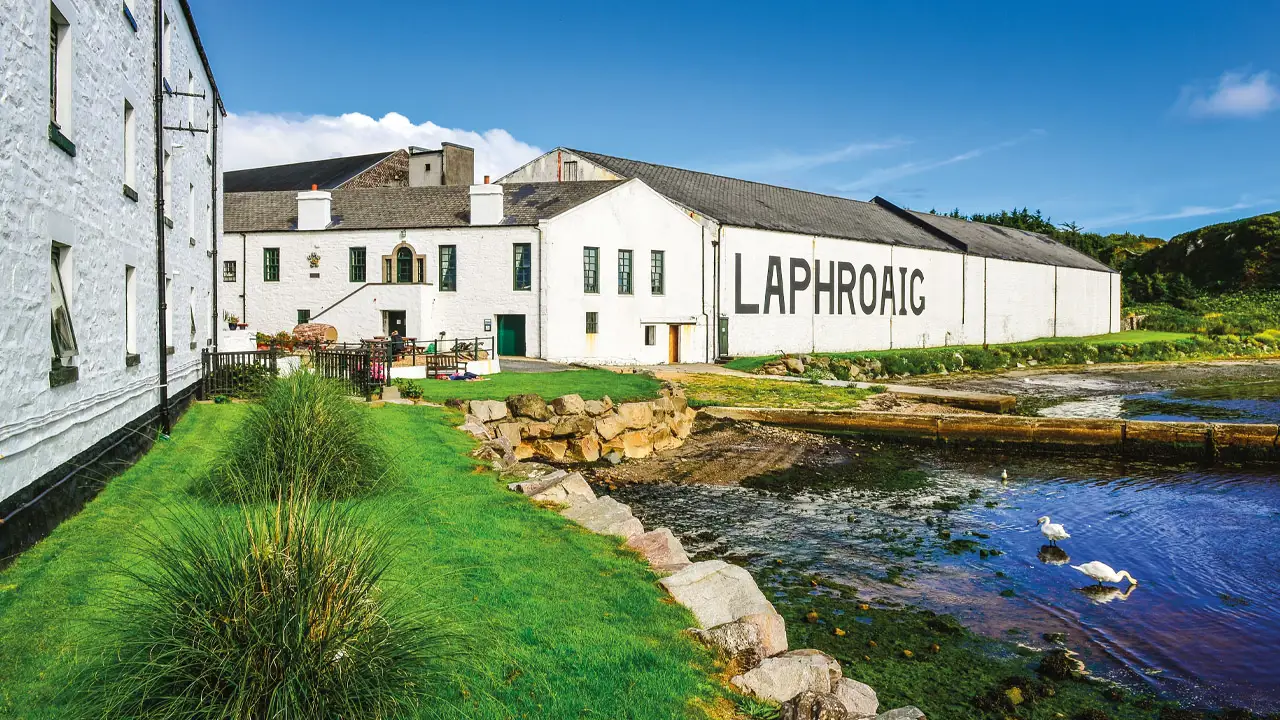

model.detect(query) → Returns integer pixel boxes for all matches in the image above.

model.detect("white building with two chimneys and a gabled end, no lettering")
[219,179,708,364]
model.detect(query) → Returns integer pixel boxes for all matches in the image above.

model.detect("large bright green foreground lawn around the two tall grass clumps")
[0,404,723,719]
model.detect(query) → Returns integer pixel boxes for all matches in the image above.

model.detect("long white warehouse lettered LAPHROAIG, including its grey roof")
[498,147,1120,357]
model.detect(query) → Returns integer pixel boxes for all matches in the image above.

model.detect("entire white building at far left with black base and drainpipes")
[0,0,224,543]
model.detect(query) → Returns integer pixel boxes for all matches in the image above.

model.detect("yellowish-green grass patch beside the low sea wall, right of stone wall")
[680,375,876,409]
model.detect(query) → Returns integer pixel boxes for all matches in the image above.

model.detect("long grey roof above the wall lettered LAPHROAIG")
[564,147,1114,272]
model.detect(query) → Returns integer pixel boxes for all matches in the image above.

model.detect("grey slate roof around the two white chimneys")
[223,181,622,232]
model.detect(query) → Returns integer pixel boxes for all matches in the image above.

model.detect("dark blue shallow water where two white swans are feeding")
[613,441,1280,712]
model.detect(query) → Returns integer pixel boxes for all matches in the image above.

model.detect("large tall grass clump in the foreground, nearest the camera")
[84,498,466,720]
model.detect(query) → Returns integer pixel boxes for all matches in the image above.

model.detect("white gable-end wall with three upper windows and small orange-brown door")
[543,181,708,364]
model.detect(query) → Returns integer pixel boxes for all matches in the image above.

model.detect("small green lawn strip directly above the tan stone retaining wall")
[415,369,662,402]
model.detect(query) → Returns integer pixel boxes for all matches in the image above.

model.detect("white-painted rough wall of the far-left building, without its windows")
[0,0,221,500]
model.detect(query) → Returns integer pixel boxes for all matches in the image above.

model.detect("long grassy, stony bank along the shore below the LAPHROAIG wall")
[728,331,1280,379]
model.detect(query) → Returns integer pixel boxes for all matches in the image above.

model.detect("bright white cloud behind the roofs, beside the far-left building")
[223,113,543,179]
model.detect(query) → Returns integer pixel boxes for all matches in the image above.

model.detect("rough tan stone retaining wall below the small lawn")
[463,386,698,462]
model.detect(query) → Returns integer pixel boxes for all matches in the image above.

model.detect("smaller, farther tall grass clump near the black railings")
[201,372,390,502]
